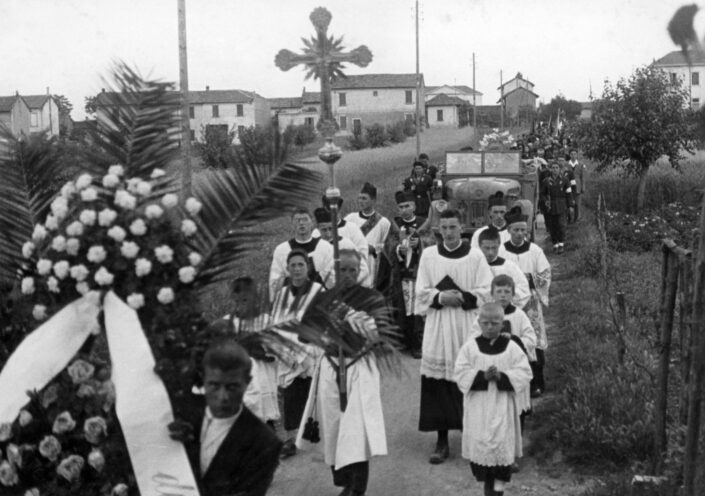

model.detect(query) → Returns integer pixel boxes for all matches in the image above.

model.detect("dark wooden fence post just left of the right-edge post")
[653,240,679,475]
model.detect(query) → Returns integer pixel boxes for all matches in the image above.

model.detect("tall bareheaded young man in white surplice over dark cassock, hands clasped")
[415,209,492,464]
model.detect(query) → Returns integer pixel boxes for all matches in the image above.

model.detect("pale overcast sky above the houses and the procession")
[0,0,705,120]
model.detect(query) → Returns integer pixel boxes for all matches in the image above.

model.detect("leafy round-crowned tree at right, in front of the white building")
[577,66,694,210]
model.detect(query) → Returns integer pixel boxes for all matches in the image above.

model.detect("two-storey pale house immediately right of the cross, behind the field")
[331,74,426,134]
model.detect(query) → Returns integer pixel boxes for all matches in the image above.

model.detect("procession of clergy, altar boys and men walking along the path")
[171,145,584,496]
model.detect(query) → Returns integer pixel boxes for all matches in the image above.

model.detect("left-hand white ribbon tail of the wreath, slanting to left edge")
[0,292,100,425]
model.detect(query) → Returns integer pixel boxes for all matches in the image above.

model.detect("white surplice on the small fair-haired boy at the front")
[455,339,532,467]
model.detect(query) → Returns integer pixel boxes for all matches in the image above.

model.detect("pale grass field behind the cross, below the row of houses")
[194,128,476,317]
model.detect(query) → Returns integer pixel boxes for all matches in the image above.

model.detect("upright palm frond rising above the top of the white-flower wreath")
[84,62,181,177]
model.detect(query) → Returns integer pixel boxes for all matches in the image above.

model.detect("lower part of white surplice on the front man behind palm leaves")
[296,357,387,470]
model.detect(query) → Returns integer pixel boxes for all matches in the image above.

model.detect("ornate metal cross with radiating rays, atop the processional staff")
[274,7,372,136]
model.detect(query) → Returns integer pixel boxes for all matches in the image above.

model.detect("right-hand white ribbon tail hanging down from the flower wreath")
[103,291,198,496]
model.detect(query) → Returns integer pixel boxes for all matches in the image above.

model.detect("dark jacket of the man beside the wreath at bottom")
[186,395,282,496]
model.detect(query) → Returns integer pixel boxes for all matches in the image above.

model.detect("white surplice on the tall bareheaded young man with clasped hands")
[415,243,492,381]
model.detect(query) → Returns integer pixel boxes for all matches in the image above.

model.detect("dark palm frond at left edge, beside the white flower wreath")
[0,127,63,286]
